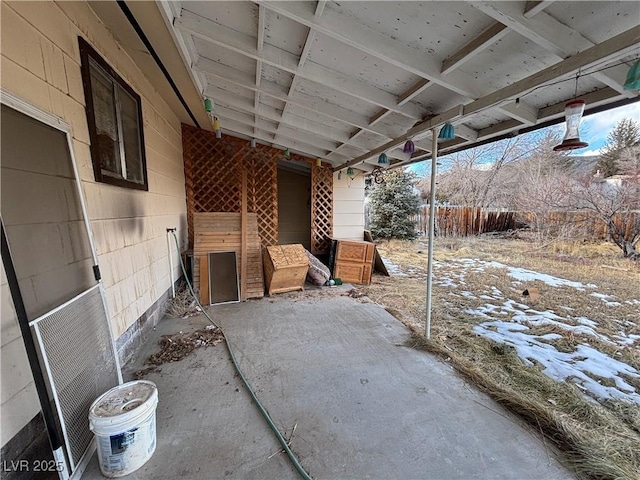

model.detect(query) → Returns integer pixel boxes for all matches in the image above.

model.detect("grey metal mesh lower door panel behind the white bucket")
[31,285,118,468]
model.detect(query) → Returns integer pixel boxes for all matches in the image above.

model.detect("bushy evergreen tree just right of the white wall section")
[369,169,420,240]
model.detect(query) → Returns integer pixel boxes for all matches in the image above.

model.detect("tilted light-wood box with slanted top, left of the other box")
[262,244,309,295]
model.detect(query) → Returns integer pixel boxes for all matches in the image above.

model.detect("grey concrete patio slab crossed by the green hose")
[83,289,575,480]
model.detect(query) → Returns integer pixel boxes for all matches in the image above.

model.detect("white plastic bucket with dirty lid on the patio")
[89,380,158,478]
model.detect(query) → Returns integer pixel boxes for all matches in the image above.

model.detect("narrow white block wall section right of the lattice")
[333,170,364,240]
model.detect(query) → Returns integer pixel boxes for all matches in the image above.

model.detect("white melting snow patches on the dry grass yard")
[385,258,640,405]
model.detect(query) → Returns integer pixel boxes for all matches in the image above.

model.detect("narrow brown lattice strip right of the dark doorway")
[311,163,333,254]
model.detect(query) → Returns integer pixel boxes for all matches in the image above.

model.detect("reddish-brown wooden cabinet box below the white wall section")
[333,240,376,285]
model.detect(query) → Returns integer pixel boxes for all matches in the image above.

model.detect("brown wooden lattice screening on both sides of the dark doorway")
[182,125,333,253]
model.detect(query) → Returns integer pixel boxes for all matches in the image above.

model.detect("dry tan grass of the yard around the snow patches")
[363,238,640,480]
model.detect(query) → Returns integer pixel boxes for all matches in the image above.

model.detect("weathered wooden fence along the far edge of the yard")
[413,206,640,241]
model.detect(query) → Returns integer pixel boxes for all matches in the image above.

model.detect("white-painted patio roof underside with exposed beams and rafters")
[94,0,640,170]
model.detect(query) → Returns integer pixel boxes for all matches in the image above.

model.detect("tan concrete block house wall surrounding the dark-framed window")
[0,1,187,445]
